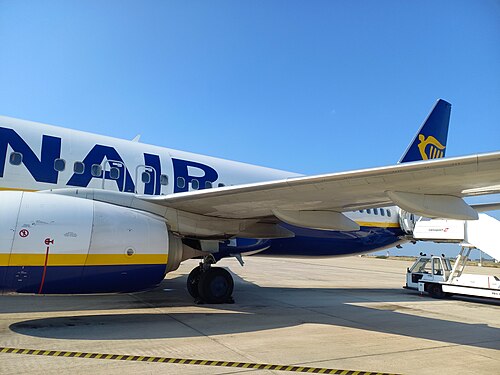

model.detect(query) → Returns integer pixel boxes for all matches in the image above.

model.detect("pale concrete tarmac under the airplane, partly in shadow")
[0,256,500,375]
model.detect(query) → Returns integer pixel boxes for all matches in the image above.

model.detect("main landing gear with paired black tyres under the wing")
[187,255,234,303]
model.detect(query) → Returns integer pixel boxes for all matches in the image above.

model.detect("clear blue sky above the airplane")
[0,0,500,258]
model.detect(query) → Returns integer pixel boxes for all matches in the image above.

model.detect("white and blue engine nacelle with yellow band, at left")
[0,192,194,294]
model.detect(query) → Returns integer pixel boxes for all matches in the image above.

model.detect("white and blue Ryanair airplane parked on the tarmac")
[0,99,500,303]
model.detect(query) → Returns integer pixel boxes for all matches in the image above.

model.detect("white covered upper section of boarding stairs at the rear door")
[413,214,500,262]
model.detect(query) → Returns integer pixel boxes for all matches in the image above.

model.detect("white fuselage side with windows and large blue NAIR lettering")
[0,117,398,227]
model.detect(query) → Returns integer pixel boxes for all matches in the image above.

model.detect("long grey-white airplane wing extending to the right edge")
[137,152,500,229]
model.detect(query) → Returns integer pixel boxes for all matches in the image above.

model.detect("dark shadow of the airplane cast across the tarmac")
[4,275,500,349]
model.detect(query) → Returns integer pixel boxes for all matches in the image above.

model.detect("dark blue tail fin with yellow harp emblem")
[399,99,451,163]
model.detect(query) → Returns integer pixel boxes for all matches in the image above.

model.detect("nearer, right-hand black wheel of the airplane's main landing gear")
[198,267,234,303]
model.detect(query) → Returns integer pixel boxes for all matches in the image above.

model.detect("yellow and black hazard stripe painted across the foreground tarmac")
[0,347,395,375]
